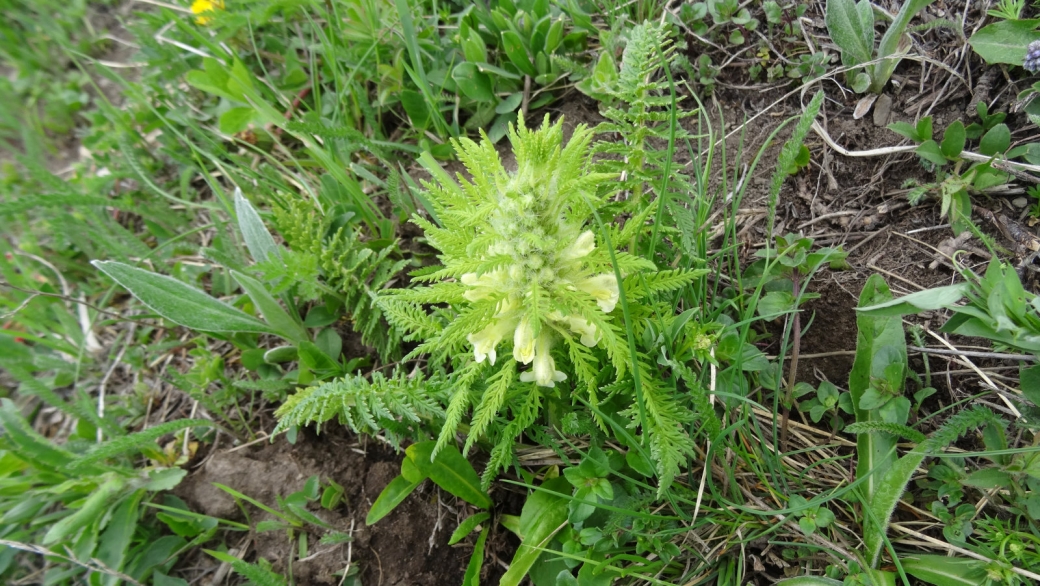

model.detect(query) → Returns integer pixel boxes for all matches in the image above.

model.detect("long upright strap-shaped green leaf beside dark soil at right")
[849,275,907,502]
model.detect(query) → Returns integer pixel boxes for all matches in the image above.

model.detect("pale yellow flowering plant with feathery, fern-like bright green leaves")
[381,117,701,491]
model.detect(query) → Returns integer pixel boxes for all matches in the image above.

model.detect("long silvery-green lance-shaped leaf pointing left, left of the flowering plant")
[92,260,278,334]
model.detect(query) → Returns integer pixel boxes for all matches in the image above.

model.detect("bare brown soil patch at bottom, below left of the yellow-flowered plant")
[177,431,499,586]
